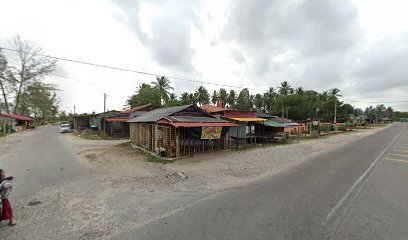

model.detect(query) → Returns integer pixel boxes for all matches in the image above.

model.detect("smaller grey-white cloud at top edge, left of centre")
[116,0,200,73]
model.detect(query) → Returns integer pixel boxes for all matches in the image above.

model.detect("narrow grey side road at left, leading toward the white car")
[0,126,88,203]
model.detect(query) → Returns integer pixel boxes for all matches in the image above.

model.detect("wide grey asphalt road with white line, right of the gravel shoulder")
[112,124,408,240]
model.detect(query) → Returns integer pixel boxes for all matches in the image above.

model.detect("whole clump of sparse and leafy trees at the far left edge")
[0,36,59,120]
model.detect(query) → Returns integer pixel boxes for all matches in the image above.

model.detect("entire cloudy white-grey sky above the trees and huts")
[0,0,408,113]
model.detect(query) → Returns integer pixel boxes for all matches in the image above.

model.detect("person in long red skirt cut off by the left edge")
[0,169,16,226]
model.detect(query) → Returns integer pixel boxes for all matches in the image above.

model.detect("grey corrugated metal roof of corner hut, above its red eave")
[129,104,217,122]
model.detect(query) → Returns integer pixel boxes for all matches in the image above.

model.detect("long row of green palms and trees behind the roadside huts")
[126,76,402,122]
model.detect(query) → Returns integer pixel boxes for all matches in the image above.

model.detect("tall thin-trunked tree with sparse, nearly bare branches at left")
[8,36,57,113]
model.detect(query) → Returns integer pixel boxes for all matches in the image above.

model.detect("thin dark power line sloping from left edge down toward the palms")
[0,46,267,91]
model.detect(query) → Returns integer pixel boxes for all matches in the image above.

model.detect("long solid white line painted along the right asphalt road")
[321,133,401,225]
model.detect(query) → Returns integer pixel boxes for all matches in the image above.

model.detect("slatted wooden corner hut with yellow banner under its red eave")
[128,104,238,158]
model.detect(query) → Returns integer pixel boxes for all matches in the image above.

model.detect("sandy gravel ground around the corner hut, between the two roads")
[0,128,384,240]
